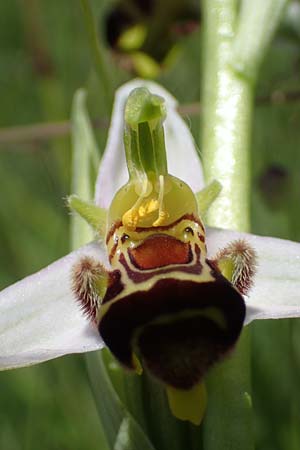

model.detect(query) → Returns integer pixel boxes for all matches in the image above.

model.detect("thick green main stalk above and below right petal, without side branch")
[202,0,254,442]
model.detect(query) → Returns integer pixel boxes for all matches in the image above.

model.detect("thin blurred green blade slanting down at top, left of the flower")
[81,0,114,108]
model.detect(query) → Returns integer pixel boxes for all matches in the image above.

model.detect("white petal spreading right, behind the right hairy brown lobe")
[207,228,300,324]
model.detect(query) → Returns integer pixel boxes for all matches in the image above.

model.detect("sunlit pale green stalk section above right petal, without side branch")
[202,0,253,231]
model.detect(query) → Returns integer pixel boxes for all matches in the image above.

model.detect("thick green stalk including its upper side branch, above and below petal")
[201,0,287,450]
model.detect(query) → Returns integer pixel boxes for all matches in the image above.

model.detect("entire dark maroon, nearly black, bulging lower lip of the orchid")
[99,268,246,389]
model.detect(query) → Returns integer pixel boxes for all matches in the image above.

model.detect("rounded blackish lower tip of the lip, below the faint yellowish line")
[138,315,229,389]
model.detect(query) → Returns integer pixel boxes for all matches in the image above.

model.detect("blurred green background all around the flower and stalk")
[0,0,300,450]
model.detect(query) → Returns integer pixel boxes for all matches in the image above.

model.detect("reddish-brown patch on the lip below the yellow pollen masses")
[128,235,192,270]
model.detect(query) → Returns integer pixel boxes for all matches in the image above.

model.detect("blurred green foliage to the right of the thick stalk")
[252,25,300,450]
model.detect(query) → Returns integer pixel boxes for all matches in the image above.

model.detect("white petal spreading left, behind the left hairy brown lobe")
[0,243,106,370]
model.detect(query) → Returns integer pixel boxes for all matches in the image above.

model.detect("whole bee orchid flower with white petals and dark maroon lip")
[0,80,300,423]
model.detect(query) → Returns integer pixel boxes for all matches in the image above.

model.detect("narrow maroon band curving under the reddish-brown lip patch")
[119,246,202,283]
